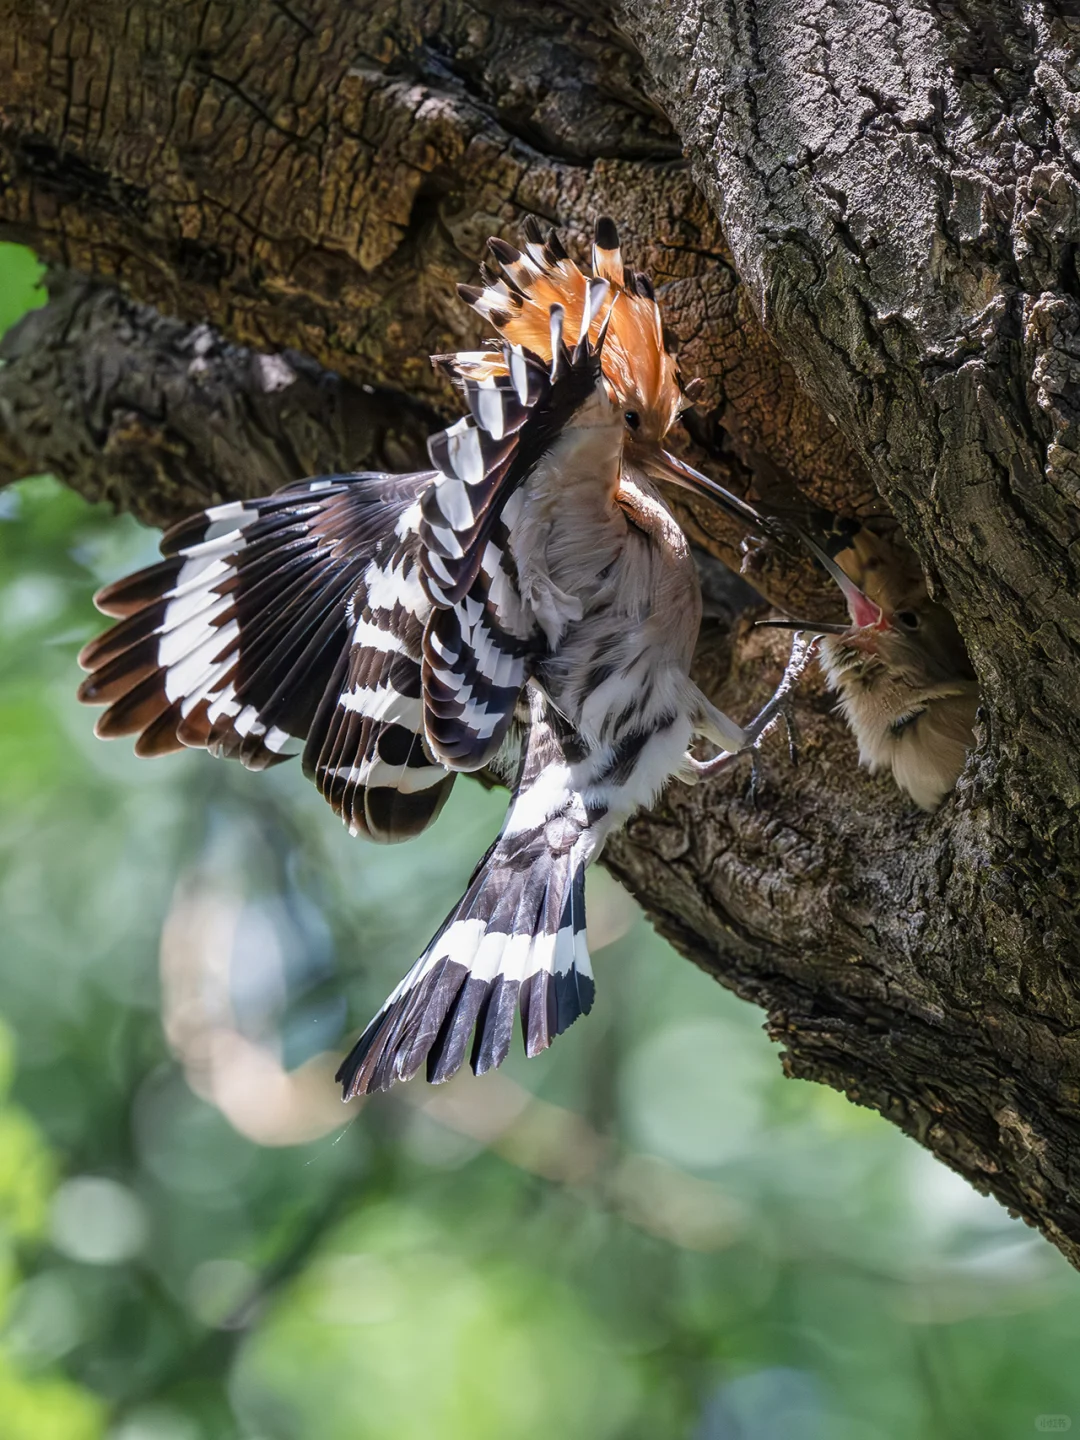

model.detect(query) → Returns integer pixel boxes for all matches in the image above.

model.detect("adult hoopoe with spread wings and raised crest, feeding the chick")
[79,220,776,1099]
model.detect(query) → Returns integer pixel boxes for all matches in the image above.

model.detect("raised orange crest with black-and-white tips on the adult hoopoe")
[458,219,690,441]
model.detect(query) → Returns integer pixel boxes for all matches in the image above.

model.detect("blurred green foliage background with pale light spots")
[0,248,1080,1440]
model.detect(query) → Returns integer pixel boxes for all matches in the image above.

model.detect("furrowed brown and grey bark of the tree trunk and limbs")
[0,0,1080,1263]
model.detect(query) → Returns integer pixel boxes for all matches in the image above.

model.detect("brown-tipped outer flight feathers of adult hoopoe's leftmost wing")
[79,478,363,769]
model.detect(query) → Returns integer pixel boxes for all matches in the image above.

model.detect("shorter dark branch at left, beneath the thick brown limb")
[0,276,439,526]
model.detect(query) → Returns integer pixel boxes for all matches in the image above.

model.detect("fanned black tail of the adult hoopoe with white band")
[337,691,599,1099]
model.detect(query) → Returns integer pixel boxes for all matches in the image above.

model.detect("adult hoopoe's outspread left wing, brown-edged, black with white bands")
[79,472,452,840]
